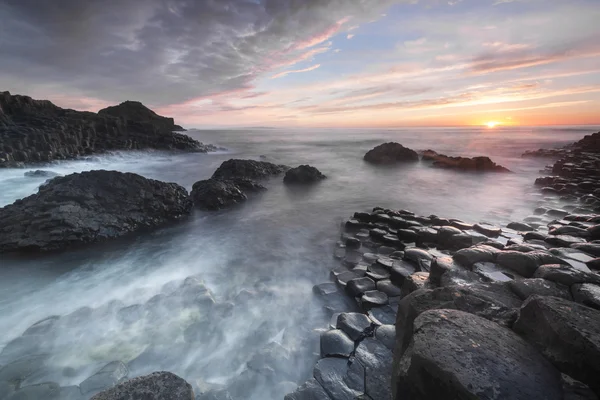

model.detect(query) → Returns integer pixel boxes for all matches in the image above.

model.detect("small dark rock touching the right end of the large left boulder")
[190,179,248,211]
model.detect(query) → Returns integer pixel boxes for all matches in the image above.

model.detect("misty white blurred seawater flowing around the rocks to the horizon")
[0,128,593,399]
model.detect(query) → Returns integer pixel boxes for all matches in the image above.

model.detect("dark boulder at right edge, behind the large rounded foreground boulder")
[513,296,600,395]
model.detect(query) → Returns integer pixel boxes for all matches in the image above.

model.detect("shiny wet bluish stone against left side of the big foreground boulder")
[356,338,393,400]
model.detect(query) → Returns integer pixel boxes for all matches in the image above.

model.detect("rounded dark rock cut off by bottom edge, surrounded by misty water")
[91,372,194,400]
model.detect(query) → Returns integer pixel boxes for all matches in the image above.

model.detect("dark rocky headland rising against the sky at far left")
[0,92,216,168]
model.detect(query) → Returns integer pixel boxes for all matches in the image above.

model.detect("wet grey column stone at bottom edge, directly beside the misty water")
[313,358,365,400]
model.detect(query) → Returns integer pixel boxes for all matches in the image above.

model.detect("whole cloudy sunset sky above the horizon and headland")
[0,0,600,127]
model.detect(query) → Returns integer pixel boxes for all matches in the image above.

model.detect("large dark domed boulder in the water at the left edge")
[0,170,192,252]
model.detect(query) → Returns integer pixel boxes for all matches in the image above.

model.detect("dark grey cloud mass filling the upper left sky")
[0,0,404,105]
